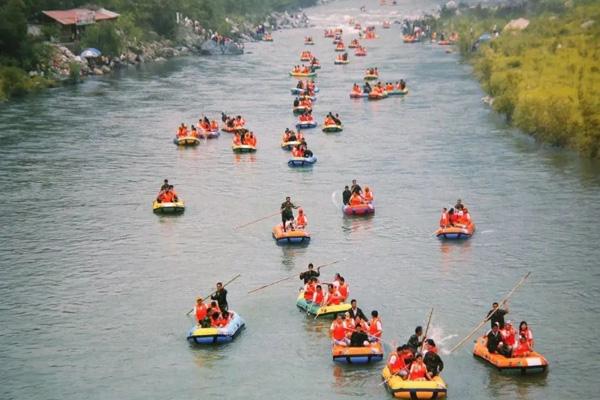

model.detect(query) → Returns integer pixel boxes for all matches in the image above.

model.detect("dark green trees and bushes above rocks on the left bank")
[0,0,316,101]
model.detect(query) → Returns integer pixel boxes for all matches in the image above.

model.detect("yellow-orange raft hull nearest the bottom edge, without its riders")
[381,367,448,400]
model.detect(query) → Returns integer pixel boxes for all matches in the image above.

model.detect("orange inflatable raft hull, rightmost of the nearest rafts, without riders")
[473,337,548,375]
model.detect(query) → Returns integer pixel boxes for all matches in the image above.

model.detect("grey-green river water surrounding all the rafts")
[0,1,600,400]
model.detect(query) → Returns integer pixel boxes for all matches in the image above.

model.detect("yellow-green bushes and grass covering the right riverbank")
[437,0,600,158]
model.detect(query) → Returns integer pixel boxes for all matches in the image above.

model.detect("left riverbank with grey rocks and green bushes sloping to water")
[0,0,316,102]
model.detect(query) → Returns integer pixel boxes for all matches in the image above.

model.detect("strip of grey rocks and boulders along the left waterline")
[44,11,310,81]
